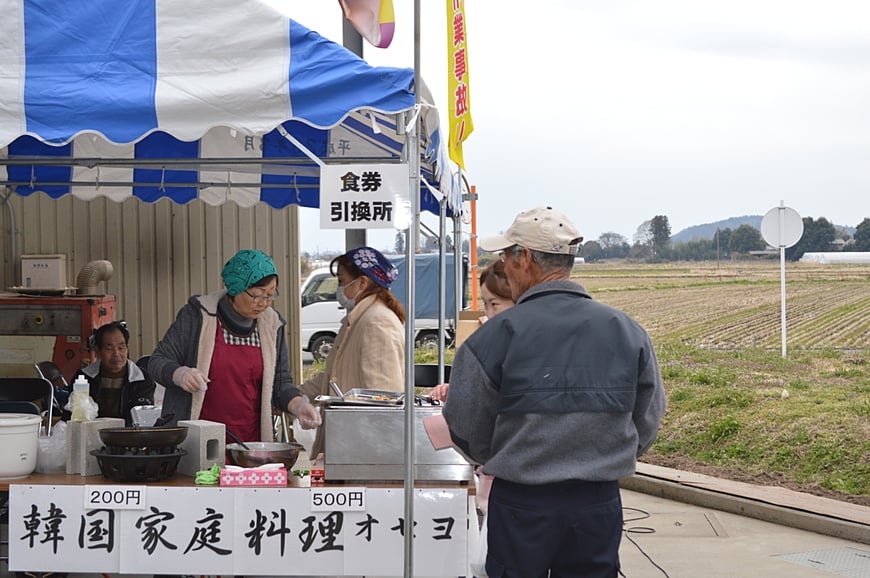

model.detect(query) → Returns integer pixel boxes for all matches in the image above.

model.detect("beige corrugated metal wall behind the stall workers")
[0,193,301,380]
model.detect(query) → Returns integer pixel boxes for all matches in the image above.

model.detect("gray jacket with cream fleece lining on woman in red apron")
[148,290,301,441]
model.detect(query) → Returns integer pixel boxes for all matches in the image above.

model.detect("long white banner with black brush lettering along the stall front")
[9,484,477,576]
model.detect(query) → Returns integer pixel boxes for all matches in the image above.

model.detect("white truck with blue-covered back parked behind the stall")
[301,254,464,361]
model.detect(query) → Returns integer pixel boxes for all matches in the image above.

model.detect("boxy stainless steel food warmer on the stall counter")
[324,406,474,484]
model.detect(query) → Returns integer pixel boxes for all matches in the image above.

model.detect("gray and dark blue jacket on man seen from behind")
[443,281,665,485]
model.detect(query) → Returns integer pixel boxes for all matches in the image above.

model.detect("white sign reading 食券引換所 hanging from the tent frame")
[320,164,409,229]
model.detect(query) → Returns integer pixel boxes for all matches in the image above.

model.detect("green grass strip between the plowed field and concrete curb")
[648,343,870,495]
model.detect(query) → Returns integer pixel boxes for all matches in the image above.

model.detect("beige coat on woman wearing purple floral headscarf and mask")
[299,295,405,457]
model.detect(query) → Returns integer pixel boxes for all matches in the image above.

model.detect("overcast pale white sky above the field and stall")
[268,0,870,251]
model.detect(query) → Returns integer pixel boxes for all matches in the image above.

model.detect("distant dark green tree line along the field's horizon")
[580,215,870,262]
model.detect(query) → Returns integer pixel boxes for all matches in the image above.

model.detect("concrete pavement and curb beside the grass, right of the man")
[620,464,870,578]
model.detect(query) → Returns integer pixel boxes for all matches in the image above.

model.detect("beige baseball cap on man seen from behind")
[478,207,583,255]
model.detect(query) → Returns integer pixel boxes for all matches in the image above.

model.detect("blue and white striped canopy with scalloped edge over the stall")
[0,0,449,210]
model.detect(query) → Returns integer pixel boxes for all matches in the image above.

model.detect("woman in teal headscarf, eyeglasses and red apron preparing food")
[148,249,320,441]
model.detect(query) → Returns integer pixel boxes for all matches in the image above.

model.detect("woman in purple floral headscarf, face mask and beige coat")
[300,247,405,456]
